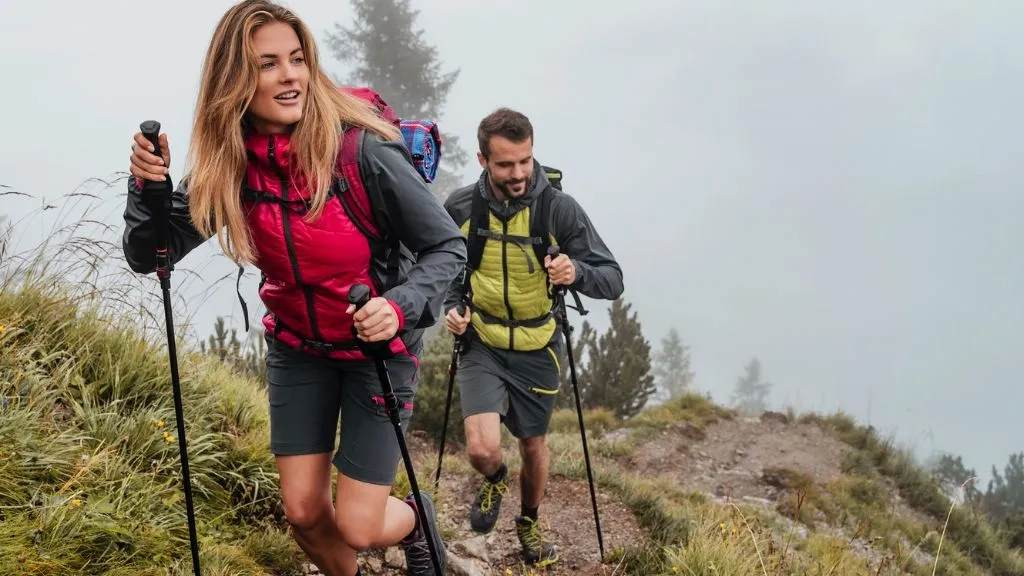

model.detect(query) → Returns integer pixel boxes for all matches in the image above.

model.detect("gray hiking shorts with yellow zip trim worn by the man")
[456,337,561,439]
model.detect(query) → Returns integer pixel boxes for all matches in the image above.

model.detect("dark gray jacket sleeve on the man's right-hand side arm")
[551,194,624,300]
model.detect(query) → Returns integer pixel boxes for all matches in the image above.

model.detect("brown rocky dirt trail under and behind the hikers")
[294,413,934,576]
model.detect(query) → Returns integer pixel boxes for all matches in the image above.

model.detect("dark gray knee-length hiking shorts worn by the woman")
[266,337,419,486]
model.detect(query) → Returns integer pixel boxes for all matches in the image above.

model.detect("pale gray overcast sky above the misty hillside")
[0,0,1024,477]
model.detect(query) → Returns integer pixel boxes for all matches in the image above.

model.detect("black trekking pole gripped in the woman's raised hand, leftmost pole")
[139,120,200,576]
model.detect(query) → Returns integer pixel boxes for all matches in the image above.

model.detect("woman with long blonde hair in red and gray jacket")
[123,0,466,576]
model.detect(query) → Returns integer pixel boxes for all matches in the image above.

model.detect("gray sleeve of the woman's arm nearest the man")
[360,133,466,330]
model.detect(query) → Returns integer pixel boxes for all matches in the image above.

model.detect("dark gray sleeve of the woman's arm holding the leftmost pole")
[121,176,207,274]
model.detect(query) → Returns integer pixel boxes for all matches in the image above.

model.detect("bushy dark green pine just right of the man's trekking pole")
[579,298,655,418]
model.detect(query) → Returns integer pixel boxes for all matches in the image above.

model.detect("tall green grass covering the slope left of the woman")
[0,243,301,576]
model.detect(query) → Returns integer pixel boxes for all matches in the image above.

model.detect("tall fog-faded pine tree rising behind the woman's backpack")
[325,0,469,199]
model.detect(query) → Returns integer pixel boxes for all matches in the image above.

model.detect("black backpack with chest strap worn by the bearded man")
[462,165,587,316]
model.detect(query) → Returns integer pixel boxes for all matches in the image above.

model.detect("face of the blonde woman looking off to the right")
[249,22,309,134]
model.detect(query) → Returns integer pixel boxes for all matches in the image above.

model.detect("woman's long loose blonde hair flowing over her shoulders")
[184,0,401,264]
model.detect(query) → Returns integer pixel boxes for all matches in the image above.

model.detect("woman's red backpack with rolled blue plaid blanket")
[234,87,441,332]
